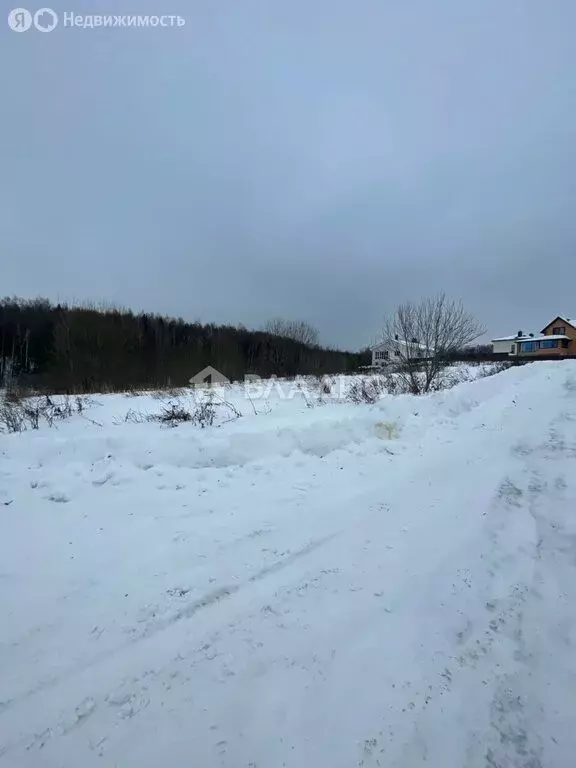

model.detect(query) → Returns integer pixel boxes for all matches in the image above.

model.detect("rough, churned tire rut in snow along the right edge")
[470,396,576,768]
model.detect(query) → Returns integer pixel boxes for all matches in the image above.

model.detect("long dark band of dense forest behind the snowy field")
[0,299,370,393]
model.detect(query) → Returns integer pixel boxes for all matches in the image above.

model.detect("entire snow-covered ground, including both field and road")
[0,361,576,768]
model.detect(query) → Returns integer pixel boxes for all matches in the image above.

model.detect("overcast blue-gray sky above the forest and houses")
[0,0,576,348]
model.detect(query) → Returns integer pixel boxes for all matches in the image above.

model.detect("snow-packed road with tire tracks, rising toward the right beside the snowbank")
[0,368,576,768]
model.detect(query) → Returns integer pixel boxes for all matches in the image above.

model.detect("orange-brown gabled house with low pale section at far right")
[492,316,576,357]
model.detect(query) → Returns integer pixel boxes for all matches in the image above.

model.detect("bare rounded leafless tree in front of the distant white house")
[382,293,486,394]
